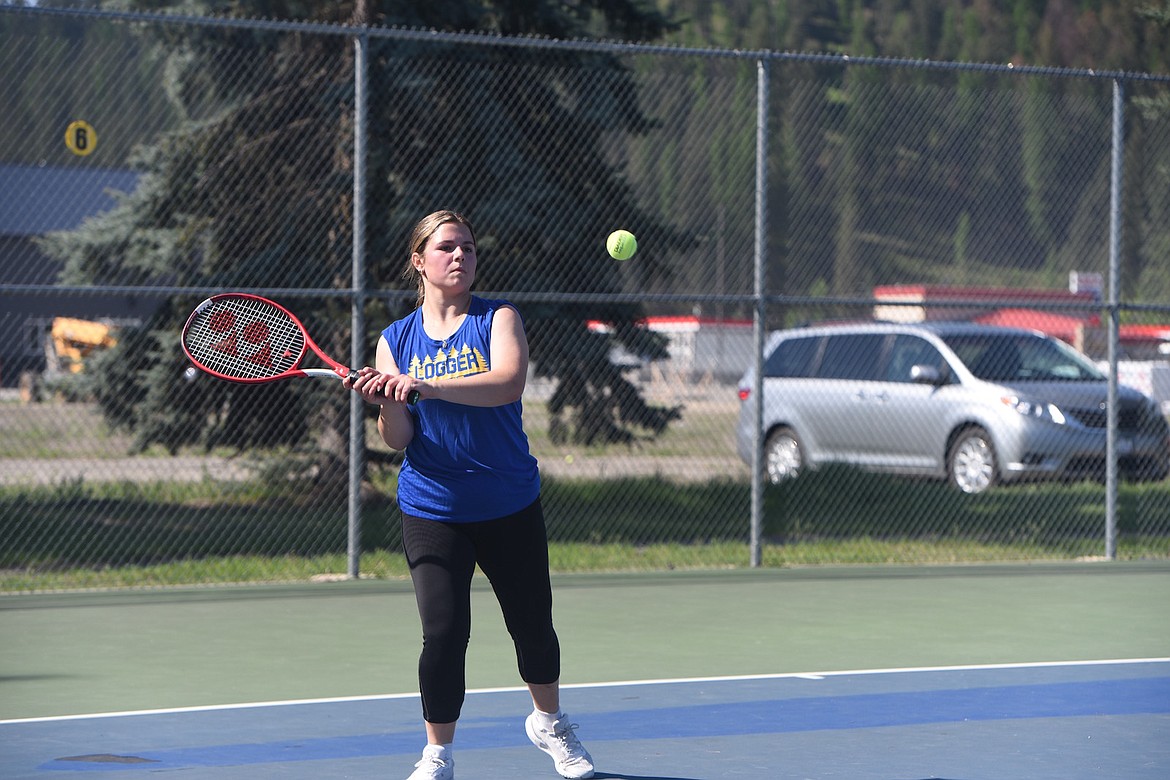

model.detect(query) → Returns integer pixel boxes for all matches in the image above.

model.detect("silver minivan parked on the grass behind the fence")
[736,323,1170,493]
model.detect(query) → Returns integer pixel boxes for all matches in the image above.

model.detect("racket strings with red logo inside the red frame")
[185,298,305,379]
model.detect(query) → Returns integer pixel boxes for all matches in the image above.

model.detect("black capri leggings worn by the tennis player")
[402,498,560,723]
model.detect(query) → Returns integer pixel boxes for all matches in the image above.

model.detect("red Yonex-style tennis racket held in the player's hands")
[183,292,419,403]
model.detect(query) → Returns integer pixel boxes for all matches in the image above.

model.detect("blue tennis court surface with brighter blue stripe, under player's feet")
[0,658,1170,780]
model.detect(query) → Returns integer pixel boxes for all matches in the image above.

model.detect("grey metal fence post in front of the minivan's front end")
[1104,78,1126,560]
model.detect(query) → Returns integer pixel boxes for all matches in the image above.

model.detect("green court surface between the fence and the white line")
[0,561,1170,720]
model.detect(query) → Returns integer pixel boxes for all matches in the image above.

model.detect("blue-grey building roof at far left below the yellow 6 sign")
[0,165,139,236]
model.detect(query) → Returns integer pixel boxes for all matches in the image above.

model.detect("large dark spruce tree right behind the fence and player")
[38,0,689,475]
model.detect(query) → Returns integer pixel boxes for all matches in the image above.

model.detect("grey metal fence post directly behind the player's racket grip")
[346,26,370,579]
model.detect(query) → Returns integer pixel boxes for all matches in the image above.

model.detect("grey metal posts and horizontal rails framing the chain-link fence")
[0,6,1170,578]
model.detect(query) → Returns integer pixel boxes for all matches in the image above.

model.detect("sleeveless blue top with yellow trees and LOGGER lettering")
[381,296,541,523]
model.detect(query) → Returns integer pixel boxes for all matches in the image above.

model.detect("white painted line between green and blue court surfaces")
[0,657,1170,726]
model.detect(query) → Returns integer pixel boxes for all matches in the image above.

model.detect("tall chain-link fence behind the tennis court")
[0,6,1170,592]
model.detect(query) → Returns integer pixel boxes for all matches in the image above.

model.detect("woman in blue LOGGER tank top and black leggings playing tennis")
[345,210,593,780]
